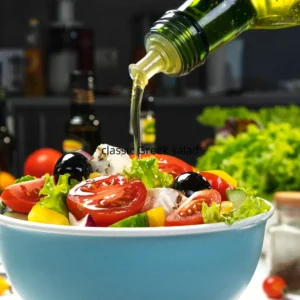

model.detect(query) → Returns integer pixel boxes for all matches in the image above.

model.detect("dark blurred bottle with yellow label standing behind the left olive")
[63,71,101,154]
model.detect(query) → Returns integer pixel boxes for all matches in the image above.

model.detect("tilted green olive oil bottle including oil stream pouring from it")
[129,0,300,154]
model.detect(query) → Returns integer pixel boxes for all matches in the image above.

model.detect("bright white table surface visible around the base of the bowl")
[0,260,300,300]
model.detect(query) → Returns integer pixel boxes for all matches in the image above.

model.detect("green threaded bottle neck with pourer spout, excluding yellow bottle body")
[129,0,256,85]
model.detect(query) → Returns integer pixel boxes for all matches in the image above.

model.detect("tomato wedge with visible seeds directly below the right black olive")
[165,190,222,226]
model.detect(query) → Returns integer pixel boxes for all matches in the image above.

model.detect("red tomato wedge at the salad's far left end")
[1,178,45,214]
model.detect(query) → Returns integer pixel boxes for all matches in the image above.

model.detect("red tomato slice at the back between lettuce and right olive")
[130,153,193,179]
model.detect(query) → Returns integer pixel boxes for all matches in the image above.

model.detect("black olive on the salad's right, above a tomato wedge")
[172,172,211,197]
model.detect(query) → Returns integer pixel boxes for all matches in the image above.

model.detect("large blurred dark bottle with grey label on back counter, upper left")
[48,0,94,95]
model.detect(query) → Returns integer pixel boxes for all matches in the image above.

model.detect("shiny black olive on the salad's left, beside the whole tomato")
[54,152,93,182]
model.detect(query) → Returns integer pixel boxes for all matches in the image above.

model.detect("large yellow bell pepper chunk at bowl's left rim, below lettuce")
[28,204,70,226]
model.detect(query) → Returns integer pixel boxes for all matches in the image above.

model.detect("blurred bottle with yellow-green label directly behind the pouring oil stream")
[129,92,156,153]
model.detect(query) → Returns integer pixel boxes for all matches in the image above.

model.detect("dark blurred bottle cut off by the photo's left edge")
[0,64,14,173]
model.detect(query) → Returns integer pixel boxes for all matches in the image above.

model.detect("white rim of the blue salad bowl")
[0,200,275,238]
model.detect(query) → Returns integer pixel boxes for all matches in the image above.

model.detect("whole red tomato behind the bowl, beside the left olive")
[24,148,62,178]
